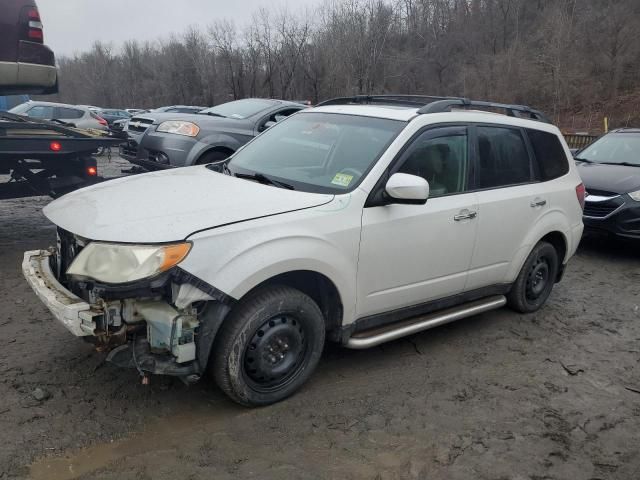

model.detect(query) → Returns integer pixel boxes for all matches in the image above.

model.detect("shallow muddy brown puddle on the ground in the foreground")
[29,405,244,480]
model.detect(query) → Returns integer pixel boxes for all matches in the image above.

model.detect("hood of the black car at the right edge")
[578,162,640,194]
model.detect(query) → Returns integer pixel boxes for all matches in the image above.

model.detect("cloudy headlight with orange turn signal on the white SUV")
[67,242,191,283]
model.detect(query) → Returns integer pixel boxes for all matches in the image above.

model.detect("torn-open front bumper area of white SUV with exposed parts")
[22,249,230,383]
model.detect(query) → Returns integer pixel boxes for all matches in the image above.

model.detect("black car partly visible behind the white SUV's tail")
[575,128,640,239]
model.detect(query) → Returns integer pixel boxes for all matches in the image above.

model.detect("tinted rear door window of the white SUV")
[476,127,532,189]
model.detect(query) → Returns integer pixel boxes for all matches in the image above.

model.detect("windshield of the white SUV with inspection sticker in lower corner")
[229,113,406,193]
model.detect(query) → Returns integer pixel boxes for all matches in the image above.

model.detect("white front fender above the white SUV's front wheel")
[180,197,361,322]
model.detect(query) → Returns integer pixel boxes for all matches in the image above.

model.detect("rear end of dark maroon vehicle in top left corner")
[0,0,58,95]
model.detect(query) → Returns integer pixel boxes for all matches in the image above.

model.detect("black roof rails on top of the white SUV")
[316,95,551,123]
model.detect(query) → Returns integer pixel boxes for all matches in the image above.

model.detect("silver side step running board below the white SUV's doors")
[346,295,507,349]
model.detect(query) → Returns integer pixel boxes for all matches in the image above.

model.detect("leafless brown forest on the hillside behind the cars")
[48,0,640,129]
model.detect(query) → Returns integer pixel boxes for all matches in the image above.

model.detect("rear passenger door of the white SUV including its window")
[465,125,549,291]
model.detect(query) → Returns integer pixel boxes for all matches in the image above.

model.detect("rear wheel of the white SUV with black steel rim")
[507,242,559,313]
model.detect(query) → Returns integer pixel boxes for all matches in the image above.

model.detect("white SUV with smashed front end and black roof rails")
[23,97,584,405]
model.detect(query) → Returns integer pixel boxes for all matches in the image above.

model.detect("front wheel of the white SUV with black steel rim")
[211,285,325,407]
